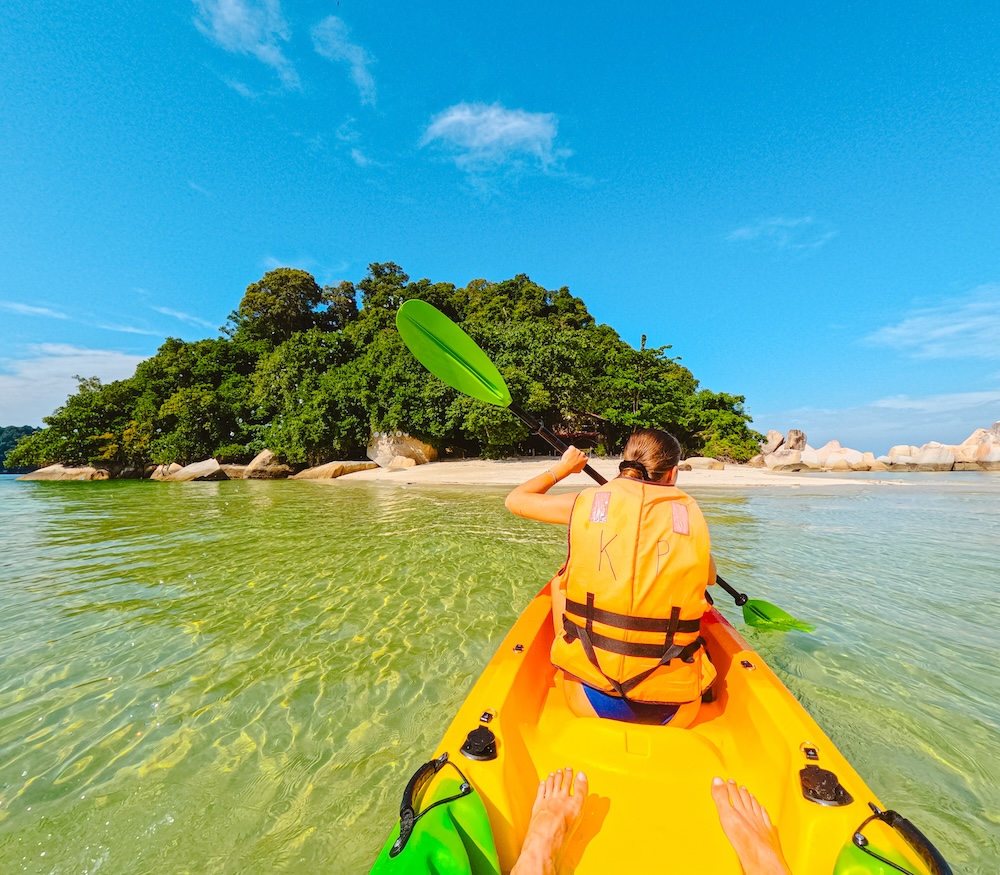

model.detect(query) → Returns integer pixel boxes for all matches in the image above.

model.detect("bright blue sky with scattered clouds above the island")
[0,0,1000,452]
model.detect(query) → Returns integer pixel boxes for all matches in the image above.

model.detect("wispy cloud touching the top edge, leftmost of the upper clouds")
[194,0,301,88]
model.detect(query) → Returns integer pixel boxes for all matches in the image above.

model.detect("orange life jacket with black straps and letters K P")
[552,477,715,704]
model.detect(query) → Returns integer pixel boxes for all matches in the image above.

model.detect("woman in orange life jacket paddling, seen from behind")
[506,429,715,726]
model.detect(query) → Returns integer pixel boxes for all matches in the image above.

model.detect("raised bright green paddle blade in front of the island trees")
[396,299,511,407]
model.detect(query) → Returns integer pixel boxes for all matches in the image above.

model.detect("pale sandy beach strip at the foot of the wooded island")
[338,456,900,489]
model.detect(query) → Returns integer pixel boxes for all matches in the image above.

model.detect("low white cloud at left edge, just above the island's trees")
[0,343,145,425]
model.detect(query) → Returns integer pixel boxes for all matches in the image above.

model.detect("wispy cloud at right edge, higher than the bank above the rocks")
[866,285,1000,359]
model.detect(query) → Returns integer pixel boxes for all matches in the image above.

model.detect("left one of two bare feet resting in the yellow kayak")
[510,768,587,875]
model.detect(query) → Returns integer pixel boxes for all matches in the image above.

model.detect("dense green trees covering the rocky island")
[0,262,760,467]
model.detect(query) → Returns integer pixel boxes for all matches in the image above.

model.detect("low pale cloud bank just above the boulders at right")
[754,389,1000,455]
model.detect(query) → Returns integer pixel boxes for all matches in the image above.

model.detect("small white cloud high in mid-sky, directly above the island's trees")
[420,103,572,172]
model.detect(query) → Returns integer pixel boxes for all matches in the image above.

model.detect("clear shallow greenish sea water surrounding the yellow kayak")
[0,474,1000,875]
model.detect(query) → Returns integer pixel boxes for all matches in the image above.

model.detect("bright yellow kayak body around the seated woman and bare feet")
[435,587,923,875]
